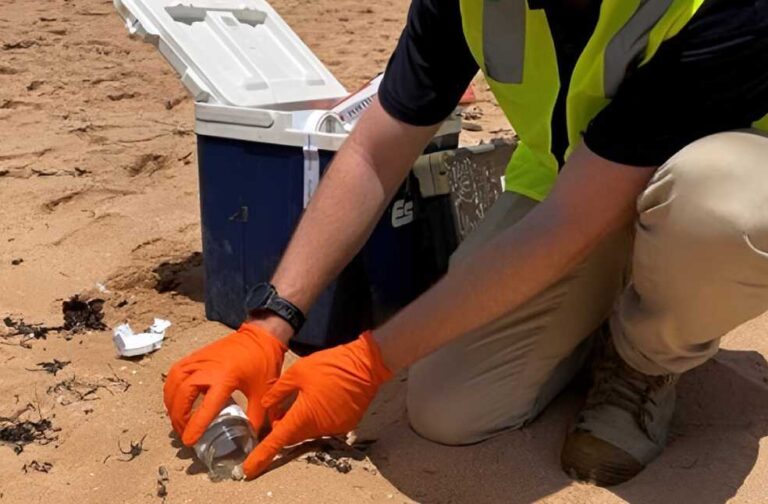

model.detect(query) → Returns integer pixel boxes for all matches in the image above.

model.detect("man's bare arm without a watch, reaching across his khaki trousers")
[374,145,654,371]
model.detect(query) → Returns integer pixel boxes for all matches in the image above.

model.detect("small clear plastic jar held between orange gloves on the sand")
[195,401,257,481]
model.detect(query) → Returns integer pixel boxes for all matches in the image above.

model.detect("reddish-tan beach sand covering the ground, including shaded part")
[0,0,768,504]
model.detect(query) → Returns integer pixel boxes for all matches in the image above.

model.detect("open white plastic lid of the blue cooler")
[114,0,347,108]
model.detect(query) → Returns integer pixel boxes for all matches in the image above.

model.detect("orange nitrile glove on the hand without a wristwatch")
[243,331,392,478]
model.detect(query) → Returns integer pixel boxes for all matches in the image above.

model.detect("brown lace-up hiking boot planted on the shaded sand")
[560,331,679,486]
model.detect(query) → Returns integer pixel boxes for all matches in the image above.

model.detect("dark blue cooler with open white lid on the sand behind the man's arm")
[114,0,461,347]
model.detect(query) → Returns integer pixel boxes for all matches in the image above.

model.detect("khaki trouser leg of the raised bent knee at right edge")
[614,132,768,374]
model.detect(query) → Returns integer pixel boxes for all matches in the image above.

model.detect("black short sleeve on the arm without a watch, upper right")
[584,0,768,166]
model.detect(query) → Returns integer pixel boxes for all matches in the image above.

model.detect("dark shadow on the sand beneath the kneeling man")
[360,350,768,504]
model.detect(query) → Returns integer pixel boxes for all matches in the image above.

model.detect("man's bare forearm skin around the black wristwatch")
[256,101,439,343]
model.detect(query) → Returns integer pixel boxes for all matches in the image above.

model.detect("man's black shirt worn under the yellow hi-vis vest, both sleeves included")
[379,0,768,166]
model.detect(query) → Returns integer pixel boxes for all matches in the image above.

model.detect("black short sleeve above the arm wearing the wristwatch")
[379,0,478,126]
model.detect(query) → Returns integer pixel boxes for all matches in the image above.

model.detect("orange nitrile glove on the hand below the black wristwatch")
[163,324,288,446]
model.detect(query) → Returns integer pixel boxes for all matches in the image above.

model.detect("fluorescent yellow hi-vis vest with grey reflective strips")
[460,0,768,201]
